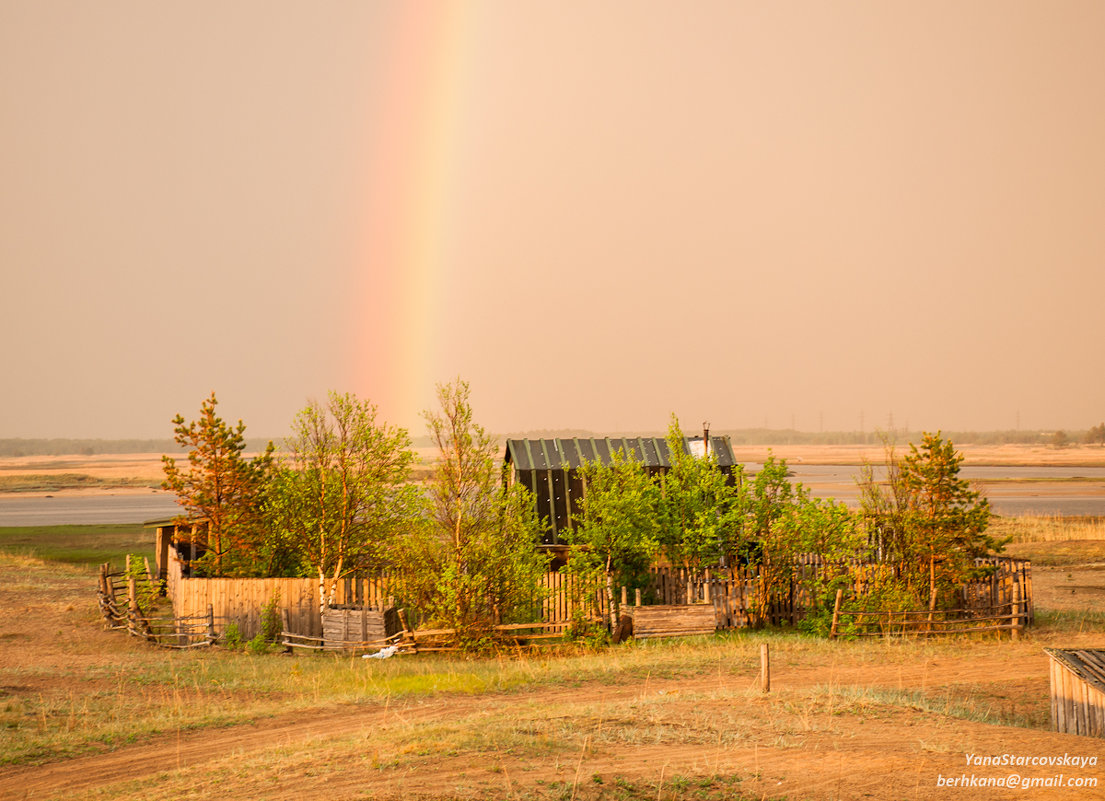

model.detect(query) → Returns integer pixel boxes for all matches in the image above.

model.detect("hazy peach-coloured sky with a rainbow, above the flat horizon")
[0,0,1105,438]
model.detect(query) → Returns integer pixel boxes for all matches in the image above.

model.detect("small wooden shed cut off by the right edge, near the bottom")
[1044,649,1105,737]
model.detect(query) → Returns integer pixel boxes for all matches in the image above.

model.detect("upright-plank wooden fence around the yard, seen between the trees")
[166,543,1033,640]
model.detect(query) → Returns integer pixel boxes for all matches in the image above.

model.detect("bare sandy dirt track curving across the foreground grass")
[0,653,1105,799]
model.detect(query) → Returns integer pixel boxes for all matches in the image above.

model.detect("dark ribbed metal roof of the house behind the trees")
[504,436,736,471]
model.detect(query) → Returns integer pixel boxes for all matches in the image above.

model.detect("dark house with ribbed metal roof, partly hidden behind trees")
[503,436,736,546]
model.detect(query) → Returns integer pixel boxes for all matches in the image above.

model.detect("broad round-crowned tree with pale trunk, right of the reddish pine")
[264,392,421,610]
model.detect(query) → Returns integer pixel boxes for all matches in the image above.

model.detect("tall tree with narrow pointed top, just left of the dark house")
[415,379,548,645]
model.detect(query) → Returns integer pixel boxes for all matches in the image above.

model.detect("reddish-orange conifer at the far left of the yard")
[161,392,273,577]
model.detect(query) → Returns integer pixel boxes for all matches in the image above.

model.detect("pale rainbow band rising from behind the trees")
[354,0,476,433]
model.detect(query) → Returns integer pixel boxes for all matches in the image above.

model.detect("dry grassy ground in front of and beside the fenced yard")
[0,524,1105,801]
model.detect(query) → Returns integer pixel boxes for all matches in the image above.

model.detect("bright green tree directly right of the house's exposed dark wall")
[566,451,660,628]
